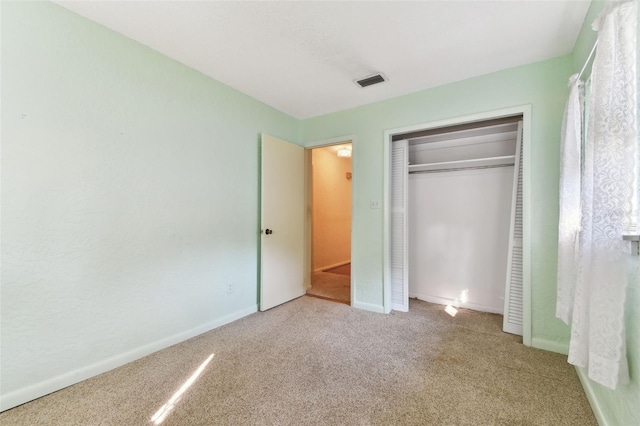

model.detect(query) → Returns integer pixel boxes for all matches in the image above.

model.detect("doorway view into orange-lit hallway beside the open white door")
[307,141,352,304]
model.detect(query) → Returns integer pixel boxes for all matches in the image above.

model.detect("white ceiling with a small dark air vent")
[57,0,589,119]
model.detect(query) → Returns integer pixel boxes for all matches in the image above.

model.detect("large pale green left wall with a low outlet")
[0,2,299,408]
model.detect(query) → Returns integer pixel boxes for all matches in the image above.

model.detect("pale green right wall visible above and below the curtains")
[572,1,640,425]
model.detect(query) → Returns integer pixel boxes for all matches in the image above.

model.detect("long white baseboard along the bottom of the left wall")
[0,305,258,411]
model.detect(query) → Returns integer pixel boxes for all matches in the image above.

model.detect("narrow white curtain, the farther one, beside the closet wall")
[556,74,584,324]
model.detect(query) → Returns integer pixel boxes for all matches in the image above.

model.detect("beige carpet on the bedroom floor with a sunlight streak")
[0,297,596,426]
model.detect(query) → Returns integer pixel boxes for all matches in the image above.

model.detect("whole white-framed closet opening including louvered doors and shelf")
[384,106,530,344]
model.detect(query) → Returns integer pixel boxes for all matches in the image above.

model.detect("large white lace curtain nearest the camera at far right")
[569,1,639,389]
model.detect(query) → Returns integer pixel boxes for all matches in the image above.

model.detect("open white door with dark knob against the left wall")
[260,134,305,311]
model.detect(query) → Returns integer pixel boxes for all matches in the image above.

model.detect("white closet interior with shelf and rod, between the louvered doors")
[407,122,518,314]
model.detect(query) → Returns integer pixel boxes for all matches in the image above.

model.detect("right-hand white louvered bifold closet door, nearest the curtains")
[502,121,523,336]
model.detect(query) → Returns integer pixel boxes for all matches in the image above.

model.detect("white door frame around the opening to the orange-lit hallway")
[304,135,357,306]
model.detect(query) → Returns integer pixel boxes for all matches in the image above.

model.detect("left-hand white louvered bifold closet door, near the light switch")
[390,140,409,312]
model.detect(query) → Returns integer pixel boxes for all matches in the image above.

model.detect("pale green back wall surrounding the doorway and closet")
[301,56,571,350]
